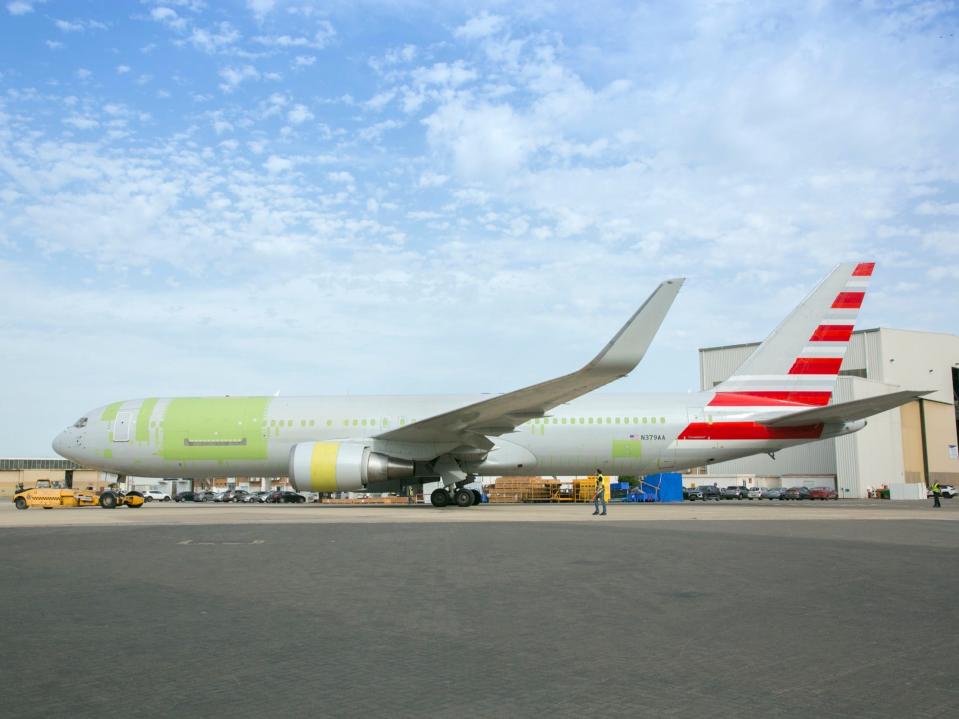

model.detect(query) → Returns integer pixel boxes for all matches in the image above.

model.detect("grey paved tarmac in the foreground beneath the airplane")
[0,502,959,718]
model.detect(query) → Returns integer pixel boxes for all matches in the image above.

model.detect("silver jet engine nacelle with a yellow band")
[290,442,413,492]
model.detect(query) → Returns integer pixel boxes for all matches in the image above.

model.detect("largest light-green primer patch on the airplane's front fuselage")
[159,397,270,461]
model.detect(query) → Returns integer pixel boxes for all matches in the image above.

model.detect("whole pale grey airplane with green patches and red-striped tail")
[53,262,927,507]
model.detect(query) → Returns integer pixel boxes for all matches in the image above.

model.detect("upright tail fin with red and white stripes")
[708,262,875,413]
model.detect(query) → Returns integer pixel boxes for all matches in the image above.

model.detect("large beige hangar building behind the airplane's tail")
[699,328,959,498]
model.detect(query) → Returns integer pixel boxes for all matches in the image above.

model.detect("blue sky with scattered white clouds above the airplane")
[0,0,959,456]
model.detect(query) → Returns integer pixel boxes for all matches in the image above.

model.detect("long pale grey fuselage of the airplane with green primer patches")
[54,392,840,478]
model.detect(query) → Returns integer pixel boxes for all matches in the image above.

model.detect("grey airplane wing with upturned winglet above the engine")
[376,278,684,448]
